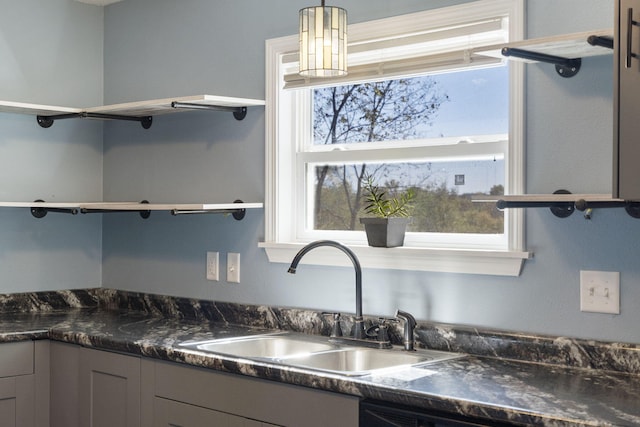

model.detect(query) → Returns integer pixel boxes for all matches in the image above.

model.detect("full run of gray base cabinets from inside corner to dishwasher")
[49,342,359,427]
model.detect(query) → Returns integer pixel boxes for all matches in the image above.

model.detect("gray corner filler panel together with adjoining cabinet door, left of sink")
[51,342,141,427]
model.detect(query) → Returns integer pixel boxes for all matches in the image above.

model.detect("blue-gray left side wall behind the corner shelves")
[0,0,104,292]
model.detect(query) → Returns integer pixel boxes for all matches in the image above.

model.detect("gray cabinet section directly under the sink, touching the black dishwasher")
[153,362,359,427]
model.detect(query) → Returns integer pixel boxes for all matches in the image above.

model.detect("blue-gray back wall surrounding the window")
[0,0,640,342]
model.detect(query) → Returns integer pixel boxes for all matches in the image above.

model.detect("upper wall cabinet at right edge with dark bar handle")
[613,0,640,200]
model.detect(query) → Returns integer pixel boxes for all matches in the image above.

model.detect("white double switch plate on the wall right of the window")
[580,270,620,314]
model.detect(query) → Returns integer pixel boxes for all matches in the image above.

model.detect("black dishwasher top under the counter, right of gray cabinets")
[360,400,508,427]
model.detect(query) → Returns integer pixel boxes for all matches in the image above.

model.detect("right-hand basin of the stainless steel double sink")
[282,348,462,375]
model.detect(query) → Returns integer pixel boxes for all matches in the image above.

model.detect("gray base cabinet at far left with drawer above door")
[0,341,49,427]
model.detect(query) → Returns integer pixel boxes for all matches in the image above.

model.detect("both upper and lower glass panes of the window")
[303,65,509,234]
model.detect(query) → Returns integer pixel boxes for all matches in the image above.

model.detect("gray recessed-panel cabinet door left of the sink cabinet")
[79,348,140,427]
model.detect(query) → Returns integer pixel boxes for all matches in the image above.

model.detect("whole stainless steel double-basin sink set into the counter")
[181,333,463,376]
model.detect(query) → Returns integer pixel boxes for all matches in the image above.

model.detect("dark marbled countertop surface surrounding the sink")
[0,308,640,426]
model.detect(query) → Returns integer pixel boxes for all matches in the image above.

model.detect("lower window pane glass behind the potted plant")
[312,160,504,234]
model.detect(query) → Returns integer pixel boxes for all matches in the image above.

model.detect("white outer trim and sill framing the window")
[259,0,532,276]
